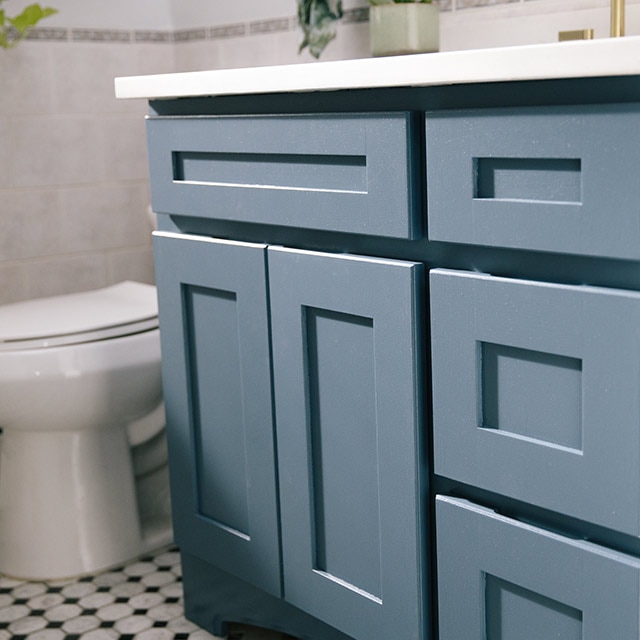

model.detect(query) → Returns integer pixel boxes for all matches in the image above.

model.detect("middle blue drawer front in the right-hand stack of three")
[430,269,640,536]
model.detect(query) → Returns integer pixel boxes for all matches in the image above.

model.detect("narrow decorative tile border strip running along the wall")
[21,0,540,44]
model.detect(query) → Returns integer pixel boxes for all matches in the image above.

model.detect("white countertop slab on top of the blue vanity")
[115,36,640,99]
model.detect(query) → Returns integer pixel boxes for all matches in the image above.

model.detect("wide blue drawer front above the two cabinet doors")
[147,113,421,238]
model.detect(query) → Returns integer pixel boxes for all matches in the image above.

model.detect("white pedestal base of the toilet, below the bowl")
[0,426,172,580]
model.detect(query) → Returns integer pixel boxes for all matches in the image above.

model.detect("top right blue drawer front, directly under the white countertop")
[426,105,640,259]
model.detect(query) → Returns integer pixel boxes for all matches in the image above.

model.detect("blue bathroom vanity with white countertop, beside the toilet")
[116,38,640,640]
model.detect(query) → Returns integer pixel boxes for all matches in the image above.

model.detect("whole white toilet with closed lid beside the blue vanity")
[0,282,172,579]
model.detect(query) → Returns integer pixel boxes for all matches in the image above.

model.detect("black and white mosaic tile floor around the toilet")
[0,547,288,640]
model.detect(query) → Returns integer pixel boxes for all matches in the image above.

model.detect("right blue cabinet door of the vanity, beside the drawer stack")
[268,248,427,640]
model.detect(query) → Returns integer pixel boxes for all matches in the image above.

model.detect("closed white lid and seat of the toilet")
[0,281,158,351]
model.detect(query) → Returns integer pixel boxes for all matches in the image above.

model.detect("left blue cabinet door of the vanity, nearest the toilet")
[154,233,280,595]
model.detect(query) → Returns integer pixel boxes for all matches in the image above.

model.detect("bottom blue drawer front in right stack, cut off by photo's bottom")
[436,496,640,640]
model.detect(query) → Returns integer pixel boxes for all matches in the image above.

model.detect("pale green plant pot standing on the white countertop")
[369,2,440,56]
